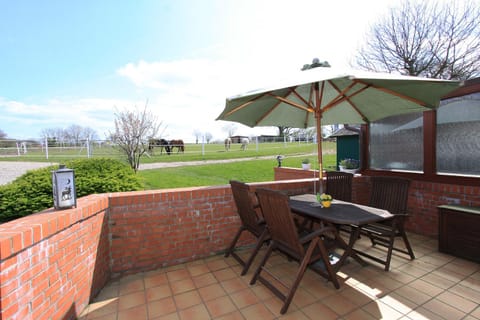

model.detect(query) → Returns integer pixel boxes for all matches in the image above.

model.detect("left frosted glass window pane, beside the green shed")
[370,113,423,171]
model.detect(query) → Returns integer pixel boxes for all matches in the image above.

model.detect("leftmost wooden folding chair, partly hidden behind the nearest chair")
[225,180,269,276]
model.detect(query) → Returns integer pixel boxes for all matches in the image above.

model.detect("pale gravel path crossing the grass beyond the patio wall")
[0,156,282,185]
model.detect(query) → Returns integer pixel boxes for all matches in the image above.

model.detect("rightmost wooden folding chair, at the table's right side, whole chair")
[356,177,415,271]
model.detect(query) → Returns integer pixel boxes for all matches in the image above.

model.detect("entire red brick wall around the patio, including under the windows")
[0,175,480,320]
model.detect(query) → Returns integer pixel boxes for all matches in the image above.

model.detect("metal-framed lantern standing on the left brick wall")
[52,164,77,209]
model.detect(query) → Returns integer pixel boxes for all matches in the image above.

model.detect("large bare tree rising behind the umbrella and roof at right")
[355,0,480,79]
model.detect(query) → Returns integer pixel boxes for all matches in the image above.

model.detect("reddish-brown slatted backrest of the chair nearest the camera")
[256,188,304,256]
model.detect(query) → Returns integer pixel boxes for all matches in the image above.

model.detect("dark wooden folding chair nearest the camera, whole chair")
[250,189,340,314]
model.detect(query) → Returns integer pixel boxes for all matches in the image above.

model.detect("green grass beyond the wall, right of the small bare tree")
[138,142,336,189]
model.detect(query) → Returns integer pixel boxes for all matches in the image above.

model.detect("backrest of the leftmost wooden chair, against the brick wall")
[230,180,260,231]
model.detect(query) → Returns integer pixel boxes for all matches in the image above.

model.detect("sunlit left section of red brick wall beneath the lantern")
[0,195,109,320]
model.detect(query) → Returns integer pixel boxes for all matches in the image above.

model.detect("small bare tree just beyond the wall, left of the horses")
[110,104,162,172]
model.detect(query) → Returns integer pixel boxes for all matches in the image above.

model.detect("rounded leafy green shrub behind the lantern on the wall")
[0,159,142,222]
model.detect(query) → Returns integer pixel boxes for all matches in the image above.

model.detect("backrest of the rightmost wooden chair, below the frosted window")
[369,177,410,214]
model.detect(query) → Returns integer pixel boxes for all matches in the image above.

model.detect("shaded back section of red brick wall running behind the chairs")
[109,181,311,277]
